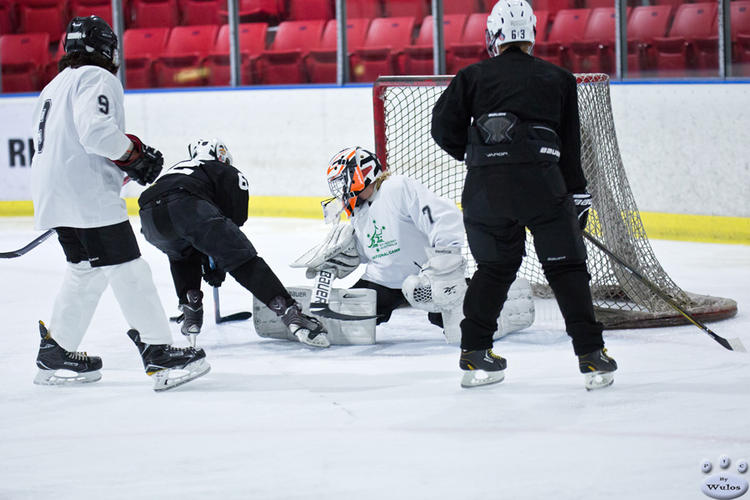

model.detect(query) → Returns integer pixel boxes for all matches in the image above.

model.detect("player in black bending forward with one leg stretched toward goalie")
[138,139,329,347]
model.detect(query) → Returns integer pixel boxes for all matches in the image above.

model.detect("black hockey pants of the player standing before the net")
[461,163,604,355]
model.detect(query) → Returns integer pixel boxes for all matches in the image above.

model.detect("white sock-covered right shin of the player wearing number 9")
[106,257,172,344]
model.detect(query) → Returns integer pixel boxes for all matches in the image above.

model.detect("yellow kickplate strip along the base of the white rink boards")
[0,200,750,245]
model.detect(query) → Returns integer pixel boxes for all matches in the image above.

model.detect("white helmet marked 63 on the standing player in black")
[485,0,536,57]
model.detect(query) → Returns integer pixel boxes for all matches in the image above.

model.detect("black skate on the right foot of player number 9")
[128,329,211,392]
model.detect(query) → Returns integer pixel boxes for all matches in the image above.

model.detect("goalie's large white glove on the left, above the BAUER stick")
[290,224,360,279]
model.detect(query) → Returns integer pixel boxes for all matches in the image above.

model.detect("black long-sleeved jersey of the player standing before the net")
[432,47,586,193]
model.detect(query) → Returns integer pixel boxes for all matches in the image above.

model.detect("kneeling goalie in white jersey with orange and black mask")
[264,147,534,343]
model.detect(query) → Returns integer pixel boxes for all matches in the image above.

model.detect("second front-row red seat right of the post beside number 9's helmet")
[154,24,219,87]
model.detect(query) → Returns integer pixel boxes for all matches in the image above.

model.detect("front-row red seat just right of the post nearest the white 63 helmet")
[627,5,672,74]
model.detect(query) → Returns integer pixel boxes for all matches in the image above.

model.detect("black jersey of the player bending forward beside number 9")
[138,160,249,226]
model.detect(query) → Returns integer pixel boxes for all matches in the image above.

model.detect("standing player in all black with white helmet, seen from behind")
[432,0,617,389]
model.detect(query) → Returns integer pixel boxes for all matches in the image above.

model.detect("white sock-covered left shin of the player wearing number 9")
[49,262,107,351]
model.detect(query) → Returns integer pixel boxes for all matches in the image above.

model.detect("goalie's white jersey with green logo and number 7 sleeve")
[351,175,464,288]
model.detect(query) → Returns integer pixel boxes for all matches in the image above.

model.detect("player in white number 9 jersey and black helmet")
[32,16,209,390]
